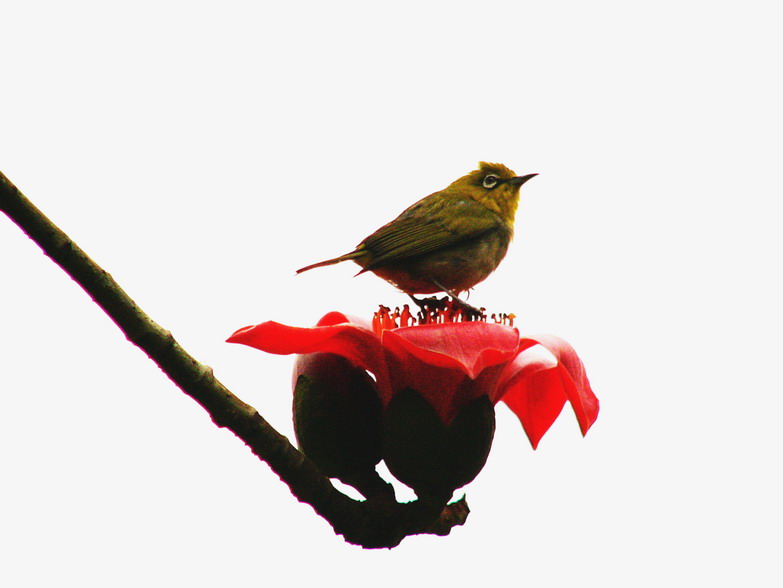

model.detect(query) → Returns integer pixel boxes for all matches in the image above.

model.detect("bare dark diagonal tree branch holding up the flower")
[0,172,469,548]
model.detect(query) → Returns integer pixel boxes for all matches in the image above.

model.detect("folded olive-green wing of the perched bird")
[362,200,501,270]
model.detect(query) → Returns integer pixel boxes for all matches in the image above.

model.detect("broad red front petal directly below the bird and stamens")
[383,322,519,379]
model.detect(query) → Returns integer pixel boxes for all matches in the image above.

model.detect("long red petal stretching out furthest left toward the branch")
[227,320,390,396]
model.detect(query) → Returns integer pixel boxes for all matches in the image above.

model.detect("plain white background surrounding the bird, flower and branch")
[0,1,783,587]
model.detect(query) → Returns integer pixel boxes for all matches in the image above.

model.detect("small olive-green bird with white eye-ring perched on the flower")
[296,161,538,300]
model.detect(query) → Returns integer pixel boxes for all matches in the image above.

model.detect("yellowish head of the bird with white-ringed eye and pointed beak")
[444,161,538,225]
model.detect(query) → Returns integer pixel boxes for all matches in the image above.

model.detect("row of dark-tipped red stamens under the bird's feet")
[372,296,516,335]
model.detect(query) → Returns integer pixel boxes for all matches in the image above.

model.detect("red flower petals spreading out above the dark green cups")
[228,312,598,449]
